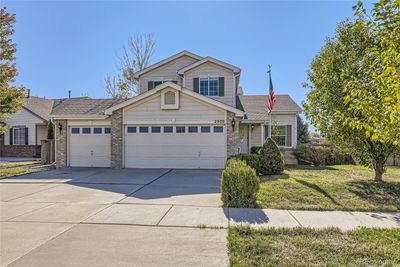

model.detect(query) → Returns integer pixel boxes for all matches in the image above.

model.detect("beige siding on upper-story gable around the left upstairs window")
[139,56,198,93]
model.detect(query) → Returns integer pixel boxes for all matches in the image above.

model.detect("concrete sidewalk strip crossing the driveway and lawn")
[6,202,400,231]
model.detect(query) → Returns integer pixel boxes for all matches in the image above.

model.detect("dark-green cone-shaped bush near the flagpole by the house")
[258,137,284,175]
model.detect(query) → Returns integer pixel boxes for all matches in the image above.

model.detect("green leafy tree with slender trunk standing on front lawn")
[303,17,396,181]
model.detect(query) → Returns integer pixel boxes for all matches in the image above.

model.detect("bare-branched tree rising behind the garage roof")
[104,34,155,98]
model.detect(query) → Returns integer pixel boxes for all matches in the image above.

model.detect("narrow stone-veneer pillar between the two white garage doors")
[111,109,123,169]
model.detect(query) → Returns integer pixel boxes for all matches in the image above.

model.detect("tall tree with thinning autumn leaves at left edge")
[0,8,25,134]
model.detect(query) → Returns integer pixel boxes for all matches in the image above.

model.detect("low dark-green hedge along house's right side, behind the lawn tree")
[293,145,354,166]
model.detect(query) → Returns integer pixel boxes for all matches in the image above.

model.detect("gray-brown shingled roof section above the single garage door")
[51,98,125,115]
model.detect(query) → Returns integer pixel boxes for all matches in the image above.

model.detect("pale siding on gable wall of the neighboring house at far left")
[4,109,44,145]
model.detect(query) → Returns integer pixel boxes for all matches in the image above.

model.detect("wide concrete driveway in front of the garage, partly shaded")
[0,168,228,266]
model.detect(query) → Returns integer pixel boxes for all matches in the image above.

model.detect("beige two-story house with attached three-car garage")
[51,51,301,169]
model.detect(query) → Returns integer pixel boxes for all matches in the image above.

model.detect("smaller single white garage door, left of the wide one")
[69,126,111,167]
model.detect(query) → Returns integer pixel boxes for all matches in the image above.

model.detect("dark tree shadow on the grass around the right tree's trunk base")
[347,180,400,211]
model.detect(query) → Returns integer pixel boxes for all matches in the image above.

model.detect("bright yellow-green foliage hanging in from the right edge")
[339,0,400,145]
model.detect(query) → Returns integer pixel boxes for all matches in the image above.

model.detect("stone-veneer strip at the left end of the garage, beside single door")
[54,120,68,168]
